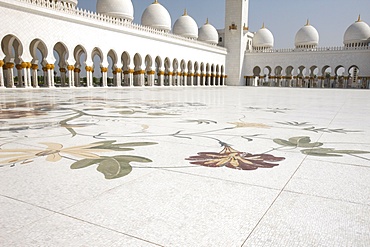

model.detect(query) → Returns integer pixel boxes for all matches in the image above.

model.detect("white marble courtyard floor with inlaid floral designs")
[0,87,370,247]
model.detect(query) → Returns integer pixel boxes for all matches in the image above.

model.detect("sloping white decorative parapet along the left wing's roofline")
[16,0,226,51]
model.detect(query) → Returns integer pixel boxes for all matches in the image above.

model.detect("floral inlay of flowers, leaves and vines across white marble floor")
[0,90,370,179]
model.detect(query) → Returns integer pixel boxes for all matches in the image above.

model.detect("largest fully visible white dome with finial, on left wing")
[141,0,171,31]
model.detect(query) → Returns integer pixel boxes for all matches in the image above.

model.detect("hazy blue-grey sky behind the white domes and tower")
[78,0,370,48]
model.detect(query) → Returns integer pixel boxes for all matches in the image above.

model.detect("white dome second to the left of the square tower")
[173,10,198,39]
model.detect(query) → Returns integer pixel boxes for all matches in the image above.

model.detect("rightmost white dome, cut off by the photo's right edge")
[343,16,370,46]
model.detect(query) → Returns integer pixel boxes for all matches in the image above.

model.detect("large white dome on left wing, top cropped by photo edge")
[96,0,134,21]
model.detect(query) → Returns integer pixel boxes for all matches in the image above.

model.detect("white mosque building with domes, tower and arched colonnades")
[0,0,370,88]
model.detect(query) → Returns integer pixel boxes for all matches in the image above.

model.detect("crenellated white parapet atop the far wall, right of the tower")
[245,46,370,53]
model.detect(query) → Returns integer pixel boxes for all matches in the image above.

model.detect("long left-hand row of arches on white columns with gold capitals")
[0,34,226,88]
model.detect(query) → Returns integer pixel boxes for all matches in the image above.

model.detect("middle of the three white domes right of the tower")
[295,20,319,48]
